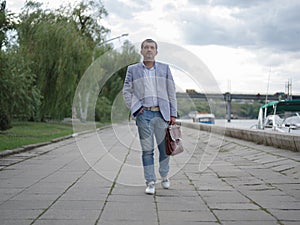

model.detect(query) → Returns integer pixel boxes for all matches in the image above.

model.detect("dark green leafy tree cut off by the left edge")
[0,1,41,130]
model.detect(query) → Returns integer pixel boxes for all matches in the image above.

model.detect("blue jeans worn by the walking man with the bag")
[136,110,170,183]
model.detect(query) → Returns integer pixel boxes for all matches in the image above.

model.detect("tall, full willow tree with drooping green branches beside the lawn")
[17,1,108,120]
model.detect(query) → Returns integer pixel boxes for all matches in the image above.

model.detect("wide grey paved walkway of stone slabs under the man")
[0,124,300,225]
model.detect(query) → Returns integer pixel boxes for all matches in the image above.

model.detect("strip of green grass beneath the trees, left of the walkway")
[0,122,73,151]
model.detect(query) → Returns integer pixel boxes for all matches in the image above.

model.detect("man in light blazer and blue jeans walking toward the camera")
[123,39,177,194]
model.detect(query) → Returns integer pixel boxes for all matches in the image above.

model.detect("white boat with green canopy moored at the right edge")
[257,99,300,134]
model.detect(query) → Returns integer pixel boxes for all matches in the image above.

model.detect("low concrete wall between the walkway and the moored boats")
[181,122,300,152]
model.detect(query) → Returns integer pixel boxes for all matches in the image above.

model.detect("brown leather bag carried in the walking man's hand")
[165,125,183,156]
